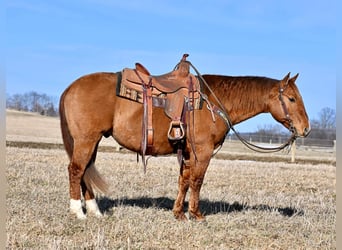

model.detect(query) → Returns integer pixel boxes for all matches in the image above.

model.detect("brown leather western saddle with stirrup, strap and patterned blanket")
[117,54,202,162]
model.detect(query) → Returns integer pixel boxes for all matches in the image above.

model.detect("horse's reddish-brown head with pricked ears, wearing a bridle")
[269,73,310,137]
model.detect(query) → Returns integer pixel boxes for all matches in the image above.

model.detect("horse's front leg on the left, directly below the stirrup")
[173,162,190,220]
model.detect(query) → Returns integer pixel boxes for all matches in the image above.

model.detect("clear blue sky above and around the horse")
[5,0,337,131]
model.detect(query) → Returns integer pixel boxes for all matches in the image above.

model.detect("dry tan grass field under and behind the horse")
[6,111,336,249]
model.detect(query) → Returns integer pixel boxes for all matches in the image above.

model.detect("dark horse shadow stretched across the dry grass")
[97,197,304,217]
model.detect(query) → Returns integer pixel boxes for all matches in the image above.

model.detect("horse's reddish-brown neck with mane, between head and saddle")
[214,77,275,124]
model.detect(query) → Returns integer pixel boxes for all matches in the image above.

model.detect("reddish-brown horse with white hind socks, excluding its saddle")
[59,59,310,221]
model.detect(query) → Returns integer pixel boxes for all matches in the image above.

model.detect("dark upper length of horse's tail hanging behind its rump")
[59,89,74,159]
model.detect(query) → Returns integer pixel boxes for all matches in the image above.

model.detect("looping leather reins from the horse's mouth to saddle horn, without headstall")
[179,61,296,155]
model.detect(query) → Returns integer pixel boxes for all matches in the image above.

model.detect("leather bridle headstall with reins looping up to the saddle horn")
[180,62,297,155]
